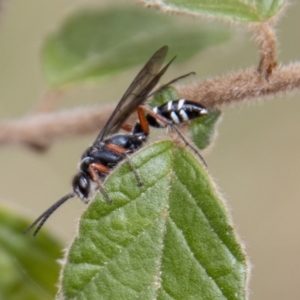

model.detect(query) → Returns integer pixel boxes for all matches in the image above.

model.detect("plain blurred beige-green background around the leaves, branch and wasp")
[0,0,300,300]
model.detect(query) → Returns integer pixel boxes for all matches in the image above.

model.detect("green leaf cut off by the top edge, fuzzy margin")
[140,0,286,22]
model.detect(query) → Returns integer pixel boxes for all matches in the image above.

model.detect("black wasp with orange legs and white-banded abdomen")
[24,46,207,236]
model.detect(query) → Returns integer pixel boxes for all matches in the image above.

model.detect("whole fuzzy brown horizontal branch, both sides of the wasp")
[0,63,300,150]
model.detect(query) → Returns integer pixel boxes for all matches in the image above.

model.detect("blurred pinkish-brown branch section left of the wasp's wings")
[0,106,113,151]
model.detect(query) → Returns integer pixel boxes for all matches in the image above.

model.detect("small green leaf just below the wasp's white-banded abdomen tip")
[189,108,221,150]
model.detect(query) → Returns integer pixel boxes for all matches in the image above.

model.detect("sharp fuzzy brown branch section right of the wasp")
[179,63,300,108]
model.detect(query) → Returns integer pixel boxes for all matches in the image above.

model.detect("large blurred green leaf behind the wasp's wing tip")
[42,7,229,87]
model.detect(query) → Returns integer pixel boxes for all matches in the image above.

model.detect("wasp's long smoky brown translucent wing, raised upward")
[94,46,170,145]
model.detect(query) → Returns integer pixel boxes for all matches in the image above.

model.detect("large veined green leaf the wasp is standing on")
[62,141,248,300]
